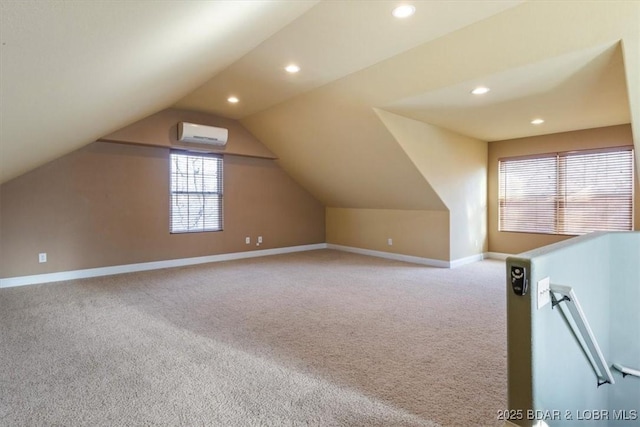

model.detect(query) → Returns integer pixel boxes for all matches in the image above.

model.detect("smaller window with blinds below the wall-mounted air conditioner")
[170,152,223,233]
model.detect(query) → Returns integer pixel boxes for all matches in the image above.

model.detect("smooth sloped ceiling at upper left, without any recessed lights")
[0,0,316,182]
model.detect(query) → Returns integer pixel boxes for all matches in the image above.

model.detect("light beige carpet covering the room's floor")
[0,250,507,426]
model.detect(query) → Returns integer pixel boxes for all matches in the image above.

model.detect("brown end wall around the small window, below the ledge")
[0,130,325,278]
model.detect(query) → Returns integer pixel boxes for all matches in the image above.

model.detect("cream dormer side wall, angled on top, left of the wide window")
[376,110,487,260]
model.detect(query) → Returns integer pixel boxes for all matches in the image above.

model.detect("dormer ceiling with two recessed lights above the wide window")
[384,43,631,141]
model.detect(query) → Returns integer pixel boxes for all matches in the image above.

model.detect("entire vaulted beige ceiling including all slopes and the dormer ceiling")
[0,0,640,209]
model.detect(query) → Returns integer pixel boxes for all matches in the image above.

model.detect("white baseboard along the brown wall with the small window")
[0,243,327,288]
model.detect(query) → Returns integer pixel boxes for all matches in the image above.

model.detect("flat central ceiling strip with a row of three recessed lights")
[175,0,522,118]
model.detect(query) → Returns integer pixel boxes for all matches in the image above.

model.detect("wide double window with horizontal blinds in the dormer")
[498,147,634,235]
